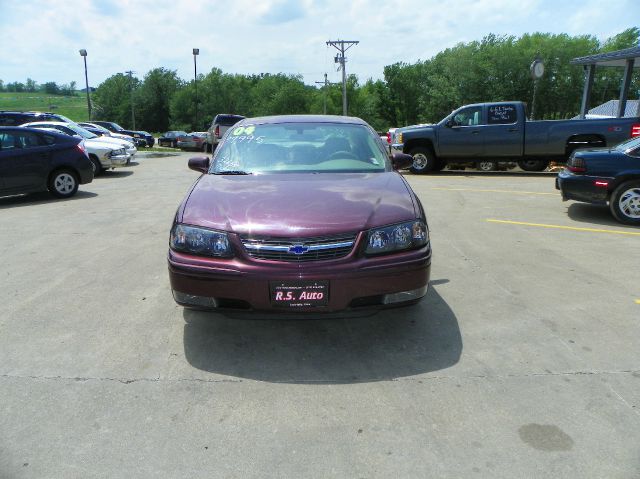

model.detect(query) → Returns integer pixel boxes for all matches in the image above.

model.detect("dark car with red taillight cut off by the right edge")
[556,136,640,225]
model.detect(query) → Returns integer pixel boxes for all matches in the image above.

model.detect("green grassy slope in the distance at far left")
[0,92,89,121]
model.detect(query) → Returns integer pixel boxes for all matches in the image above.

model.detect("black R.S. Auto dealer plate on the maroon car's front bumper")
[270,281,329,309]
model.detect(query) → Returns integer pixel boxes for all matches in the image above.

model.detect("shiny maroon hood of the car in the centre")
[179,172,418,237]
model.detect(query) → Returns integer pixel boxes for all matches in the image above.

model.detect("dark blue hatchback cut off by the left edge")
[0,127,93,198]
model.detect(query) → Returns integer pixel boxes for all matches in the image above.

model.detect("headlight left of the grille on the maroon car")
[169,224,233,258]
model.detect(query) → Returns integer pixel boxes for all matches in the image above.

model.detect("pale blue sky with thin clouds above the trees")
[0,0,640,86]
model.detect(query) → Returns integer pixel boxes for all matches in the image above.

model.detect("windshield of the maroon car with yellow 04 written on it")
[210,123,387,174]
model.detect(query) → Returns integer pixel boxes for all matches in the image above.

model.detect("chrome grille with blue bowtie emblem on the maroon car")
[240,234,356,263]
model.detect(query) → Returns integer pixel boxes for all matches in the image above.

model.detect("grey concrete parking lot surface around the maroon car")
[0,153,640,479]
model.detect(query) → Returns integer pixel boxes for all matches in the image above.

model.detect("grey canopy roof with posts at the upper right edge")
[570,47,640,119]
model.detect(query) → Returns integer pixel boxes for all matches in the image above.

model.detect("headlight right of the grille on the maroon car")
[365,221,429,254]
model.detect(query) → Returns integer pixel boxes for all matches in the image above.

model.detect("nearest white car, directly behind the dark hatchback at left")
[22,121,135,176]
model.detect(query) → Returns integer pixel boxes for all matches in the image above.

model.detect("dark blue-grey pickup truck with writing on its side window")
[392,101,640,173]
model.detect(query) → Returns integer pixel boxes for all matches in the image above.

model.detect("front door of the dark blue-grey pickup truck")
[438,106,484,159]
